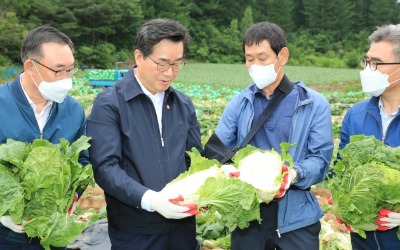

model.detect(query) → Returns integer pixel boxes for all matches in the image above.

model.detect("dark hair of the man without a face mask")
[135,18,191,57]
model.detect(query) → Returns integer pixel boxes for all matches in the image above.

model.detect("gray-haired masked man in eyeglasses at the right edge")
[339,24,400,250]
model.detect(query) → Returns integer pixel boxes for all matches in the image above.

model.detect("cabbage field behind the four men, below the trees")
[71,64,366,250]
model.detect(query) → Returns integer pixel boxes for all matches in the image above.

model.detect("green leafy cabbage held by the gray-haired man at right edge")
[328,135,400,239]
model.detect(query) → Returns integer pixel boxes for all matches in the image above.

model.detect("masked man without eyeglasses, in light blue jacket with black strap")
[211,22,333,250]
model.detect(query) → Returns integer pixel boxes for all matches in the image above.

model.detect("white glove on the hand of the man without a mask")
[150,191,192,219]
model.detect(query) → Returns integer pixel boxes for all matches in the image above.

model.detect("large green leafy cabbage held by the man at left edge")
[0,136,94,250]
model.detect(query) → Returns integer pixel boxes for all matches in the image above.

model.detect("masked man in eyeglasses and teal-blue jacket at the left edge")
[0,26,89,250]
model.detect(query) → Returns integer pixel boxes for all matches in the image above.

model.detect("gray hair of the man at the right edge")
[368,24,400,62]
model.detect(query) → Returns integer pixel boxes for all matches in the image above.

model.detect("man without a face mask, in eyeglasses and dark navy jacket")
[87,19,202,250]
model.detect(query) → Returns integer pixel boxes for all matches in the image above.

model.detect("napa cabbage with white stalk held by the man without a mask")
[163,148,260,231]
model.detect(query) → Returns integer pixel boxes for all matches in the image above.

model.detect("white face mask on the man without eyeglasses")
[249,58,281,89]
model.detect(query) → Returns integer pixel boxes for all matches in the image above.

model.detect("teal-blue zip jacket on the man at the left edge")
[0,76,89,150]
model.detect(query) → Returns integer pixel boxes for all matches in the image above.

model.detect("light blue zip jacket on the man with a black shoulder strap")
[215,78,333,234]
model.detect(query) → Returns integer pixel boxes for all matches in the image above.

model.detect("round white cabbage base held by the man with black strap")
[238,151,283,203]
